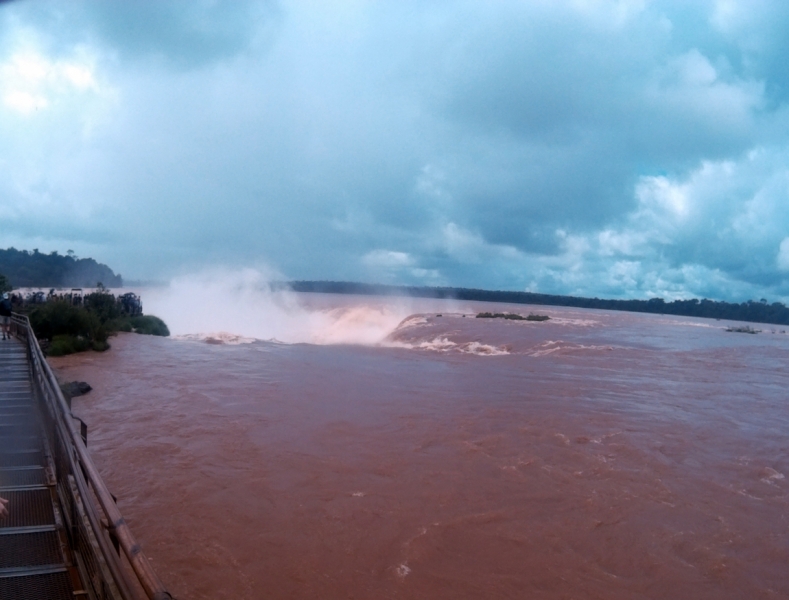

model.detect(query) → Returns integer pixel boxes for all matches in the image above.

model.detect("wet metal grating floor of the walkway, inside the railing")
[0,339,77,600]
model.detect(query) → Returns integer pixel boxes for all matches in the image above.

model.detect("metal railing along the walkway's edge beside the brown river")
[10,314,172,600]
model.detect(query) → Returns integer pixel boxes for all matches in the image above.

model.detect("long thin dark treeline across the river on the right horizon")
[289,281,789,325]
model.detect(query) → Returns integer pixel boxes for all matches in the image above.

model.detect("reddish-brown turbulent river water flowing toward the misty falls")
[50,296,789,600]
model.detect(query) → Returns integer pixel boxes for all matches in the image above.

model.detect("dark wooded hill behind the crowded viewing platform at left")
[0,248,123,288]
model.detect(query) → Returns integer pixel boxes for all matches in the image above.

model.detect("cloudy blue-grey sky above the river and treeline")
[0,0,789,302]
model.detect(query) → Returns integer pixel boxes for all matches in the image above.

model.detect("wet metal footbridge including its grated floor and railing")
[0,315,172,600]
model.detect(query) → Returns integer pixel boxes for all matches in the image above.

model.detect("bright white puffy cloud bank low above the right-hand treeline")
[510,147,789,300]
